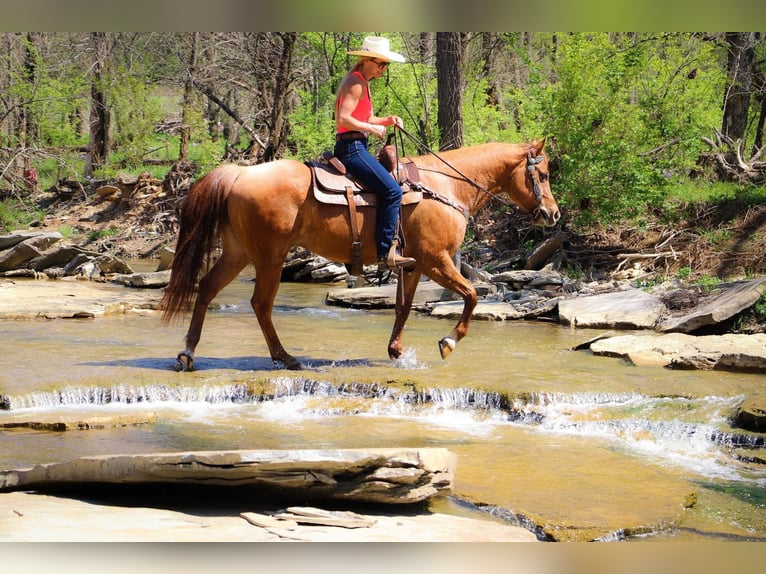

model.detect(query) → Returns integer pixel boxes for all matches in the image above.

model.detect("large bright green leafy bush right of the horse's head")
[546,33,720,223]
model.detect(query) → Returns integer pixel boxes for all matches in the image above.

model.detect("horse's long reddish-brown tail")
[160,166,237,323]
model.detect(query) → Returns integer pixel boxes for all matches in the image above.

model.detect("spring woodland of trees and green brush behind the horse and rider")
[0,32,766,281]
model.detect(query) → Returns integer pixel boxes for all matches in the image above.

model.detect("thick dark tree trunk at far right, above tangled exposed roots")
[721,32,757,141]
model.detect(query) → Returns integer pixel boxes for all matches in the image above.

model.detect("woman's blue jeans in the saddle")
[333,139,402,258]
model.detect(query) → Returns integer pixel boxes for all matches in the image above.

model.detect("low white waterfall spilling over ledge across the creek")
[5,377,766,486]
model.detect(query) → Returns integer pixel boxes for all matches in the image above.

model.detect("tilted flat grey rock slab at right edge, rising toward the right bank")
[659,277,766,333]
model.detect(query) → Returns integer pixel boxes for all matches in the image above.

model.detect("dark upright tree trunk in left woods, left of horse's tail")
[85,32,109,177]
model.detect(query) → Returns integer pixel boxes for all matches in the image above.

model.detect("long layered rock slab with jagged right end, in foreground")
[0,448,456,504]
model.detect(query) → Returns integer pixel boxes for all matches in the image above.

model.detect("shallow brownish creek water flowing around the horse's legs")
[0,266,766,541]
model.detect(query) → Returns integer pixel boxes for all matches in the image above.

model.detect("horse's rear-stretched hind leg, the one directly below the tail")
[176,251,248,371]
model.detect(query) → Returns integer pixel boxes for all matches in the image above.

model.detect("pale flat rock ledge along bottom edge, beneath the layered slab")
[0,492,536,542]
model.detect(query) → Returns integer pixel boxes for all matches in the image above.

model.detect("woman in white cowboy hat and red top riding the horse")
[334,36,415,270]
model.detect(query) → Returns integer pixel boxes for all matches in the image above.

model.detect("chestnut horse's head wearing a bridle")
[510,139,561,227]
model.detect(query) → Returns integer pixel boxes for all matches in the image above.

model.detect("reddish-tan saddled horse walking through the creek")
[160,139,560,370]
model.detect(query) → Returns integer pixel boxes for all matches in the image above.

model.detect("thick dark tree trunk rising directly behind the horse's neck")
[436,32,463,150]
